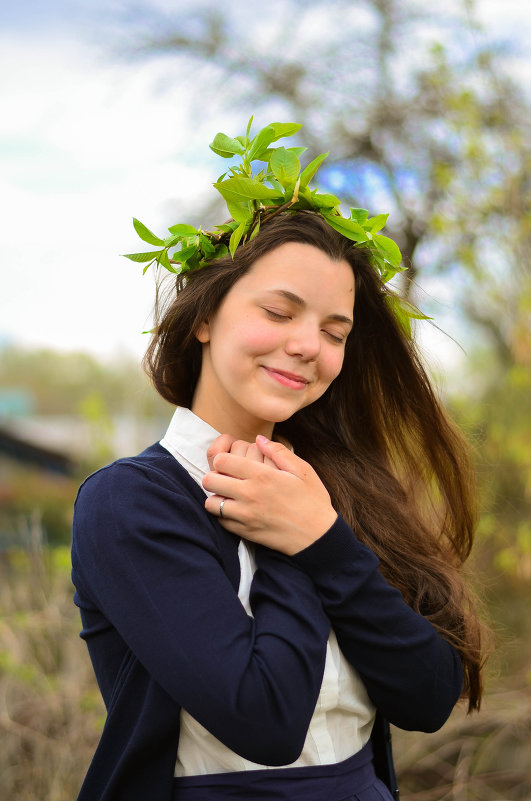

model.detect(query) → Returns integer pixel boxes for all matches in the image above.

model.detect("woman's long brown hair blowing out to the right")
[144,212,482,709]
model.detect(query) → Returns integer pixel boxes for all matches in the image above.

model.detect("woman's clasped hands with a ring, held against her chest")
[203,434,337,556]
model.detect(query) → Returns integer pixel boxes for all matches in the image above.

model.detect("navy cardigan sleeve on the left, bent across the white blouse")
[72,461,330,765]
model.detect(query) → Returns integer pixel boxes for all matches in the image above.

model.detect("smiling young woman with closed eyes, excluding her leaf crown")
[73,203,488,801]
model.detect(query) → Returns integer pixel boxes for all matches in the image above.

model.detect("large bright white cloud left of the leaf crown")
[0,32,215,353]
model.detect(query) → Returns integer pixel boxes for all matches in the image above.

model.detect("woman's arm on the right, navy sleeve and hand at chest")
[204,440,462,731]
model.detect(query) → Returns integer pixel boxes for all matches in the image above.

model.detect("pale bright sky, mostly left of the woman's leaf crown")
[0,0,531,372]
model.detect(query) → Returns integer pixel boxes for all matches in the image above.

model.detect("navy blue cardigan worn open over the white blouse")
[72,444,462,801]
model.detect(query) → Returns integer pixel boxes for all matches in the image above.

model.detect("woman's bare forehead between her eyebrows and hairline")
[235,242,354,314]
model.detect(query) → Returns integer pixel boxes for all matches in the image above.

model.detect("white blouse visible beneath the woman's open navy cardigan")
[160,407,376,776]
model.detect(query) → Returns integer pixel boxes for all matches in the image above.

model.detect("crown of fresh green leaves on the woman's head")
[125,117,426,336]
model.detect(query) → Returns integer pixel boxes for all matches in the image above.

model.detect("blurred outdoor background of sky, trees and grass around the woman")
[0,0,531,801]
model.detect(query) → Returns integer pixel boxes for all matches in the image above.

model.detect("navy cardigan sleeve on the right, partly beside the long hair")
[291,517,463,731]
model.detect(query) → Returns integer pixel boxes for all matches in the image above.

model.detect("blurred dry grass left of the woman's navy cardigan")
[0,548,104,801]
